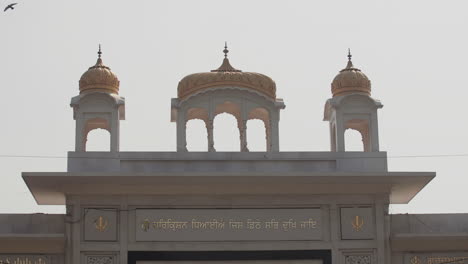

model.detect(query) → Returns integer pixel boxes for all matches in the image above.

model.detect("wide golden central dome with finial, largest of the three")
[177,46,276,99]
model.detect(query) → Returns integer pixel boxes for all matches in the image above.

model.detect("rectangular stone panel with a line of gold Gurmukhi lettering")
[135,208,322,241]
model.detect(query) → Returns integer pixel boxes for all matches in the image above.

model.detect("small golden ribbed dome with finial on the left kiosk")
[79,45,120,94]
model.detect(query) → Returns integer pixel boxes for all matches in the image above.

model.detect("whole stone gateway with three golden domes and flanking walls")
[0,47,468,264]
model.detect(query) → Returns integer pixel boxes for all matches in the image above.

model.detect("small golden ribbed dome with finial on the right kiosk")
[331,50,371,96]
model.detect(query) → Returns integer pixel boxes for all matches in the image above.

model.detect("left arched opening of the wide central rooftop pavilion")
[186,119,208,151]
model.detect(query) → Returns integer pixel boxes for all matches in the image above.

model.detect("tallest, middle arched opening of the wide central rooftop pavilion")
[213,113,240,151]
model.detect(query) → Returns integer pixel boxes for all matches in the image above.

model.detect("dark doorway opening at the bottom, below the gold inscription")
[128,250,331,264]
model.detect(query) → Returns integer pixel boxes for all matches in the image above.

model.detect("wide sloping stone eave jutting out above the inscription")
[22,172,435,205]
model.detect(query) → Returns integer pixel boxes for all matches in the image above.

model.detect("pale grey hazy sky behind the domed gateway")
[0,0,468,213]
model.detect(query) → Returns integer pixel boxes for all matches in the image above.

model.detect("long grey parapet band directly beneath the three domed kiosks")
[68,152,387,172]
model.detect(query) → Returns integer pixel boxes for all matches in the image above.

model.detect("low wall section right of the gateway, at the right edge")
[390,214,468,256]
